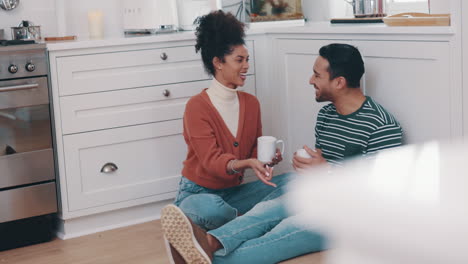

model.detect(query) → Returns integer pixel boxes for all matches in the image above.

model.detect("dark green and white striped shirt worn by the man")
[315,96,403,165]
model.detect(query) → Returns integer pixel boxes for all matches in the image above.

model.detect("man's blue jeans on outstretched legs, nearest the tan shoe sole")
[208,197,325,264]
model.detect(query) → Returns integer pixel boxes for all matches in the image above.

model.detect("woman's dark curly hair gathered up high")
[195,10,245,76]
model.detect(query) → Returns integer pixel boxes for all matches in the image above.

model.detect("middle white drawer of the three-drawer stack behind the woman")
[60,76,255,134]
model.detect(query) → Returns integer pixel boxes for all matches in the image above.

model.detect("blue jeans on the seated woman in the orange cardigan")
[174,173,295,230]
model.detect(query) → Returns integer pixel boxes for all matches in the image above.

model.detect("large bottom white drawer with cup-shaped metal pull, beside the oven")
[63,119,187,211]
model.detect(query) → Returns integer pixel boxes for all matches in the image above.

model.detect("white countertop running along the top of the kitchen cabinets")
[47,22,455,51]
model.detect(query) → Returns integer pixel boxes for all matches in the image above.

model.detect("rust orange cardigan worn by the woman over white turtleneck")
[182,90,262,189]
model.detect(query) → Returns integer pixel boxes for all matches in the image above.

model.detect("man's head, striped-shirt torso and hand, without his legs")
[293,44,402,171]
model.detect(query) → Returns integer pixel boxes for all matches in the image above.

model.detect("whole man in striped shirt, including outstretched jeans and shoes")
[161,44,402,263]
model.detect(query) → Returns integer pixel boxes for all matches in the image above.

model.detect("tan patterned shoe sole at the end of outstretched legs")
[161,204,211,264]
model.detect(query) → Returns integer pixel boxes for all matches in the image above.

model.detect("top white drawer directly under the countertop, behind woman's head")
[56,41,255,96]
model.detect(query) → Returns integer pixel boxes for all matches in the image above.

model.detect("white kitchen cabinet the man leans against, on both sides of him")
[272,36,461,169]
